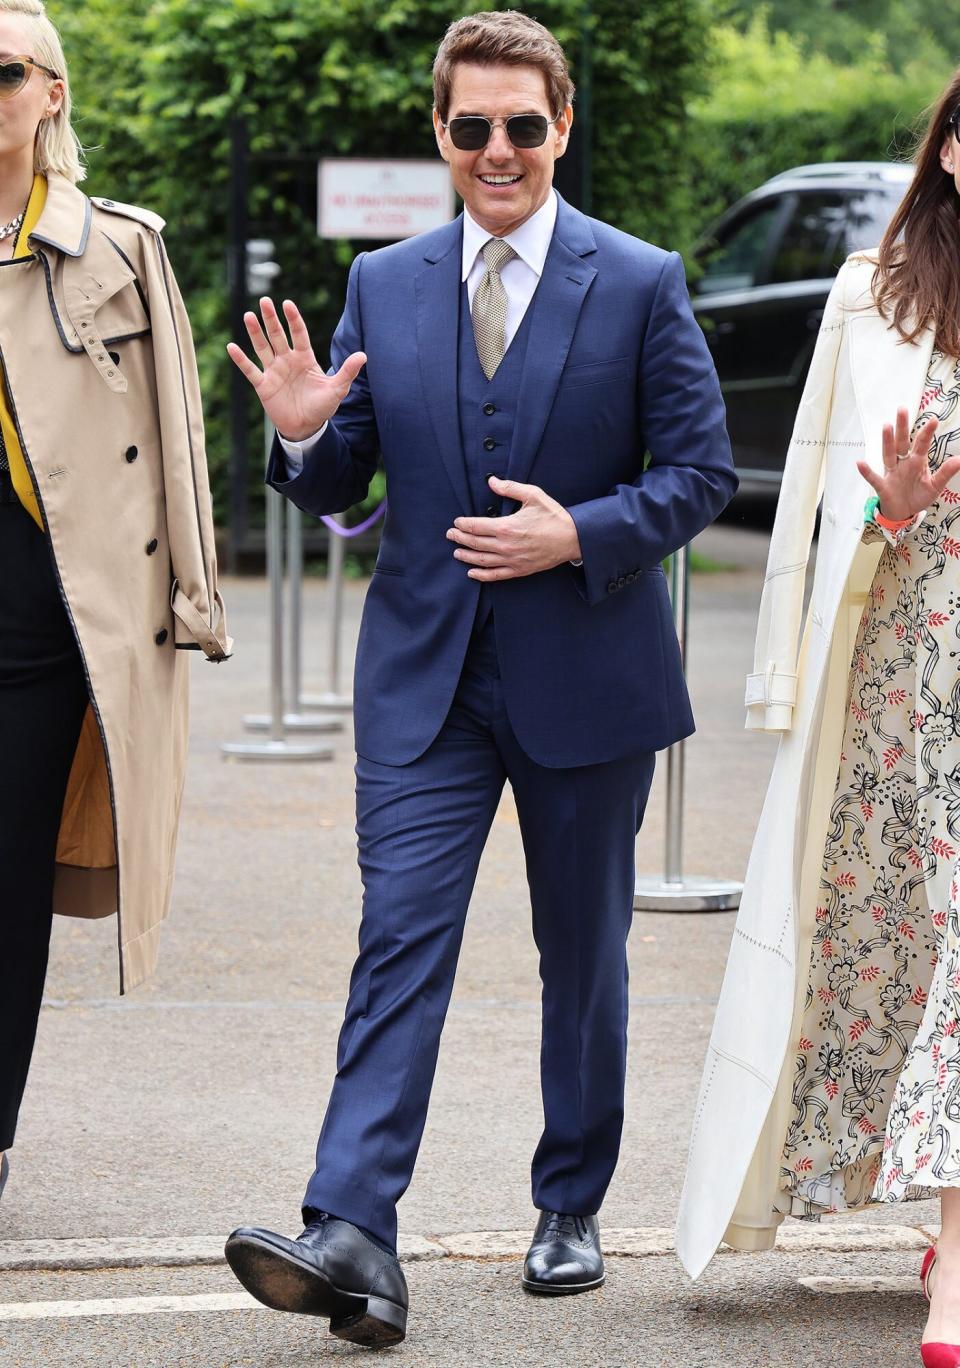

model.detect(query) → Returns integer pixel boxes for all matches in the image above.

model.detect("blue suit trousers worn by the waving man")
[304,620,654,1248]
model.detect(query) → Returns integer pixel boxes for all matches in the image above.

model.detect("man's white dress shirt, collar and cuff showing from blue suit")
[280,190,557,476]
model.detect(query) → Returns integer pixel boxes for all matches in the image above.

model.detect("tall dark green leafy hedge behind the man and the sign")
[51,0,706,528]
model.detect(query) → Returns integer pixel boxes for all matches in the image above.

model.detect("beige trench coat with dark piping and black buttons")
[0,175,230,992]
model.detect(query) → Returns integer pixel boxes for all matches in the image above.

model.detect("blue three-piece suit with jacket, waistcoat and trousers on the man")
[268,192,736,1245]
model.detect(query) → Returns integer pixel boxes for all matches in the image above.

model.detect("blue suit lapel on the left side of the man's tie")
[416,219,473,513]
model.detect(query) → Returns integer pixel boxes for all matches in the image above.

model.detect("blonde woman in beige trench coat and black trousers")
[0,0,230,1190]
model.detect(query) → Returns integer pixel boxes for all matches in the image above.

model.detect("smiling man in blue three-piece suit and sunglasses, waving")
[227,11,736,1346]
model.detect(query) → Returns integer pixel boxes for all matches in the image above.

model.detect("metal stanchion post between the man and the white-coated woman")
[633,546,743,912]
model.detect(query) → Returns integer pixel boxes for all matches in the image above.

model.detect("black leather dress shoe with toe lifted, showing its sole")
[226,1216,409,1349]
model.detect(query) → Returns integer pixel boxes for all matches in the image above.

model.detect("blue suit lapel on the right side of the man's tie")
[507,196,596,484]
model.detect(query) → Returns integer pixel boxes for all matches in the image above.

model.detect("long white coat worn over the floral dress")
[677,256,933,1278]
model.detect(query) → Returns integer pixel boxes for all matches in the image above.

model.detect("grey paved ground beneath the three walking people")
[0,508,937,1368]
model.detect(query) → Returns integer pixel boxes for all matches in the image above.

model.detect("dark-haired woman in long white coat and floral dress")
[677,71,960,1368]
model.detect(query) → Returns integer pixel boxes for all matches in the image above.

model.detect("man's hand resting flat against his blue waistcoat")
[447,475,581,583]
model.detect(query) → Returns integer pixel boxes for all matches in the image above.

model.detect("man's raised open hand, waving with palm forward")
[227,298,366,442]
